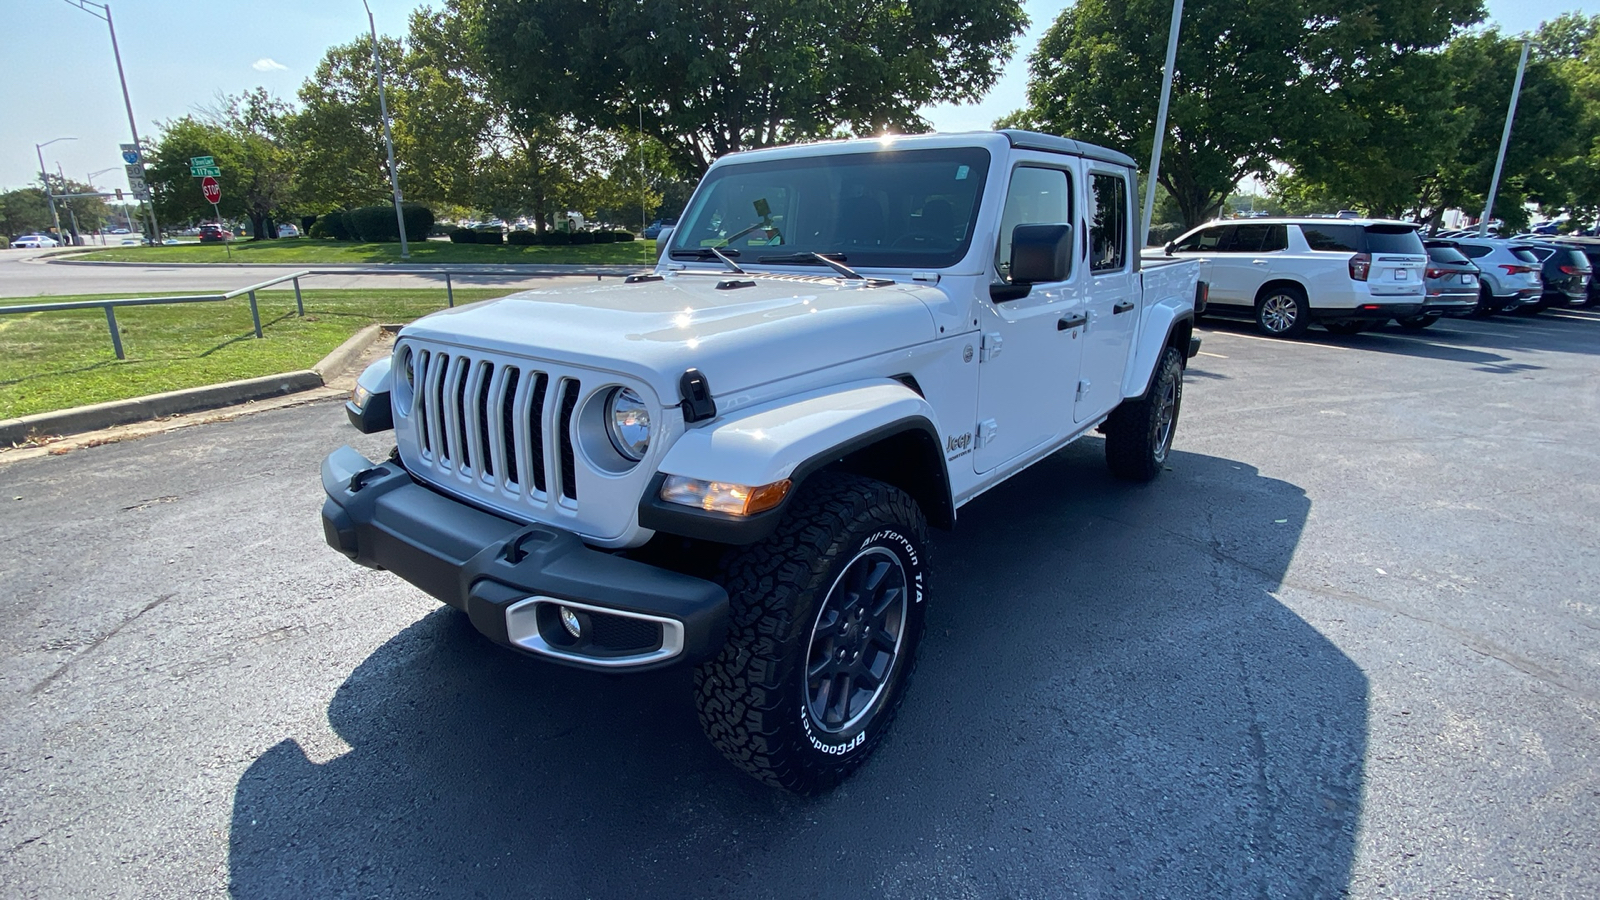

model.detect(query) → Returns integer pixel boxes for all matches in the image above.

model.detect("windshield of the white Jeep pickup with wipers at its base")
[670,147,989,269]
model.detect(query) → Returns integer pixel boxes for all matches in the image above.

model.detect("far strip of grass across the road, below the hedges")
[72,237,656,266]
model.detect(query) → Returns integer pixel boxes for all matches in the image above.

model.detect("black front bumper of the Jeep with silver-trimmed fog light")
[322,447,728,671]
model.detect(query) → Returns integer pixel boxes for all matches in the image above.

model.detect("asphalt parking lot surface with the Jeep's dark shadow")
[0,304,1600,898]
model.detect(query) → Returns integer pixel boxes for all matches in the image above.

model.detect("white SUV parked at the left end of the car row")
[1165,218,1427,338]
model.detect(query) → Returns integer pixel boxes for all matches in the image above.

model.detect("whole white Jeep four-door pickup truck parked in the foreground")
[322,131,1205,793]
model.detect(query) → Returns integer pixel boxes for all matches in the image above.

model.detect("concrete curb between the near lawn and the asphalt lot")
[0,325,400,447]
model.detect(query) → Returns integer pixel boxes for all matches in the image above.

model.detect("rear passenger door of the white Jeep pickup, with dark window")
[1072,168,1142,421]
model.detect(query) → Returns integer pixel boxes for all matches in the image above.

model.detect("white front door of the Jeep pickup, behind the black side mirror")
[973,165,1085,474]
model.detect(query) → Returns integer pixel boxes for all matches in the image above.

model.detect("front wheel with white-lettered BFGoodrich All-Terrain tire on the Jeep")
[694,474,928,794]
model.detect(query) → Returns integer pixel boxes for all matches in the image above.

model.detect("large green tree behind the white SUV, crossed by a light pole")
[1005,0,1482,226]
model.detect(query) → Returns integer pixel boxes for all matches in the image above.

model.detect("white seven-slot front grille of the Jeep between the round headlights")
[408,348,581,504]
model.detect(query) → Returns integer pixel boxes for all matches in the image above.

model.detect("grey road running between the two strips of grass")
[0,250,636,298]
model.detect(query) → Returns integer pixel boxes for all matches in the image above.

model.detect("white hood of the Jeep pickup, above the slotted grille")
[400,272,942,404]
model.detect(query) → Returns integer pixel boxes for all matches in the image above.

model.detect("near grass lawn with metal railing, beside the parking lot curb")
[0,288,514,418]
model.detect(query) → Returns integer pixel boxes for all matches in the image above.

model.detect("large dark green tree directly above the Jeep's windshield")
[473,0,1027,175]
